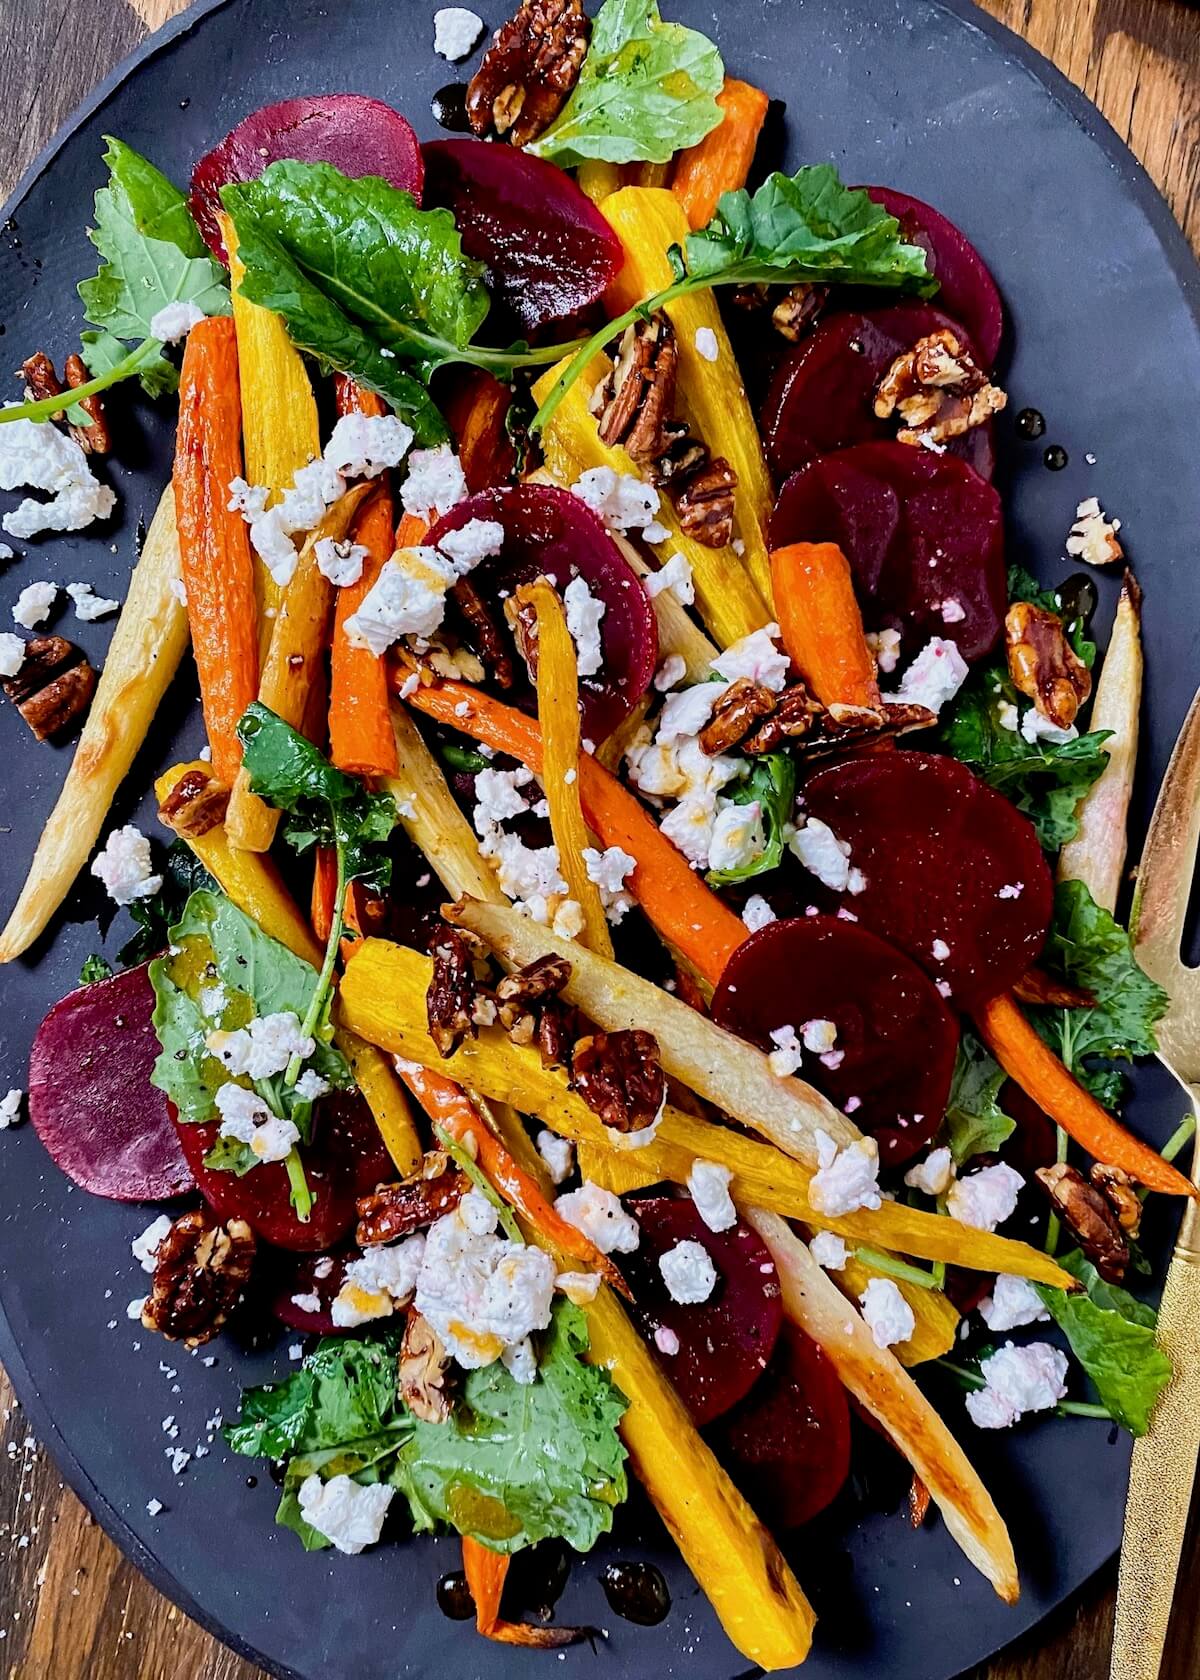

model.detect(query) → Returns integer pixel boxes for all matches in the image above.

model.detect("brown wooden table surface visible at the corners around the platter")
[0,0,1200,1680]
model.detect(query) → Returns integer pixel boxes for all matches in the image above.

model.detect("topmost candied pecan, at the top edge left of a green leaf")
[467,0,590,146]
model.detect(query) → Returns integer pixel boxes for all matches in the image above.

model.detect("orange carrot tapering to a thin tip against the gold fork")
[975,993,1200,1198]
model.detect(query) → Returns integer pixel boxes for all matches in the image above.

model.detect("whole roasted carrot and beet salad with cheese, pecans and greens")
[0,0,1193,1670]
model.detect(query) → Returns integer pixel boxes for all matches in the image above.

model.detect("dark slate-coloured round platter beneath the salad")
[0,0,1200,1680]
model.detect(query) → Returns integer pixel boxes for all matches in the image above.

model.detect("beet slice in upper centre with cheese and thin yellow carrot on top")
[429,483,659,743]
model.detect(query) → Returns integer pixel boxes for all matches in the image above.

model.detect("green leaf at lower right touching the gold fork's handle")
[1034,1250,1173,1435]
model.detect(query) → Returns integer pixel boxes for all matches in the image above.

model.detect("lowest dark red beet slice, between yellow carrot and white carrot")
[716,1324,850,1532]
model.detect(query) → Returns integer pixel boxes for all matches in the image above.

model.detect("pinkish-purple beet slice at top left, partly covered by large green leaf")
[188,94,425,262]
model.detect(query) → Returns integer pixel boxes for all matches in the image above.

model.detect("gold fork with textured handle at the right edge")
[1113,694,1200,1680]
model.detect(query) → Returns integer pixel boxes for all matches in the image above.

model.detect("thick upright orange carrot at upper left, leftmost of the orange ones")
[173,316,259,786]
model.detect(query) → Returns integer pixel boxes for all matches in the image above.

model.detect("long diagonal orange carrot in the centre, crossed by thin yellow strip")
[400,672,746,984]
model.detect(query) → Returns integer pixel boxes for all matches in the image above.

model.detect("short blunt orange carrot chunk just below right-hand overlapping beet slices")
[771,543,879,706]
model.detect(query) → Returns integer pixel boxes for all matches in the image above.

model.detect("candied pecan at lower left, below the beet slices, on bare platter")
[141,1208,255,1347]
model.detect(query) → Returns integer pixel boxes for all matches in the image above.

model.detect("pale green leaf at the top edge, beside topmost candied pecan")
[526,0,724,170]
